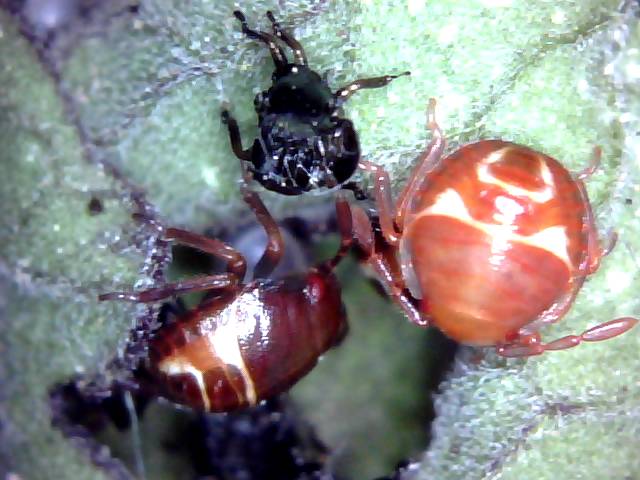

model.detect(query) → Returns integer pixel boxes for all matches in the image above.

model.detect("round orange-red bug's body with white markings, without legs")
[408,140,586,345]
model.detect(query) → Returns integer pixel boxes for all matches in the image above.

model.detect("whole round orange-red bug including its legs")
[351,99,638,356]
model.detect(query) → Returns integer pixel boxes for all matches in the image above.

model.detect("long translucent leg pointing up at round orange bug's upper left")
[395,98,446,231]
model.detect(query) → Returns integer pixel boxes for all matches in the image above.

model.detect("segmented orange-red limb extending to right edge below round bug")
[496,317,638,357]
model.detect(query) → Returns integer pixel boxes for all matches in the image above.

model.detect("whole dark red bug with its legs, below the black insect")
[100,189,352,412]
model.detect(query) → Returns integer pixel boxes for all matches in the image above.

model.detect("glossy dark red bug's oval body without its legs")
[149,271,347,412]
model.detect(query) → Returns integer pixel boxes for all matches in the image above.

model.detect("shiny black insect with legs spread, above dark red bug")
[222,11,409,195]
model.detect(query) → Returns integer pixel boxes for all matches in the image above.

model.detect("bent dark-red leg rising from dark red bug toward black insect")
[240,185,284,278]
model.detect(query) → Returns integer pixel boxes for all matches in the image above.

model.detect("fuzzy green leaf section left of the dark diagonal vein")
[0,8,142,479]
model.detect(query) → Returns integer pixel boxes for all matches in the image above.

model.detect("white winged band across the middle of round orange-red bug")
[414,188,574,271]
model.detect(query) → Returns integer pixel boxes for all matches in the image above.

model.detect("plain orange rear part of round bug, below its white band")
[407,216,570,345]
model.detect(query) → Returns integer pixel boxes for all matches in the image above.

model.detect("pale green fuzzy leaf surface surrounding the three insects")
[0,0,640,480]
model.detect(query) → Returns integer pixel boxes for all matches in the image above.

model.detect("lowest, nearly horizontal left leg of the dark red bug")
[98,273,238,303]
